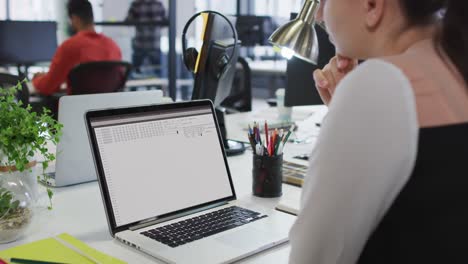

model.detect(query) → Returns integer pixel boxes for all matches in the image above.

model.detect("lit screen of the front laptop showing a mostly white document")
[88,103,234,227]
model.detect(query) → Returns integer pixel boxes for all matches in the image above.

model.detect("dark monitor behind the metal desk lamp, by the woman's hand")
[284,13,335,106]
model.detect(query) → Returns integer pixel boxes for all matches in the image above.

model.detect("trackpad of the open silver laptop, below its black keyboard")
[216,228,278,249]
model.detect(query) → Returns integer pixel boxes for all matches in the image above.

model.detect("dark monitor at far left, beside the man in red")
[0,21,57,65]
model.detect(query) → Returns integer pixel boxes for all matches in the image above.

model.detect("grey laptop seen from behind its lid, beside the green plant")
[42,90,163,187]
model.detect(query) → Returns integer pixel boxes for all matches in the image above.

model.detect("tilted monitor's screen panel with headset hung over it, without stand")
[192,14,239,107]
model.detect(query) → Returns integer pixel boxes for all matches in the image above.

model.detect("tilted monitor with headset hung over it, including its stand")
[192,13,245,156]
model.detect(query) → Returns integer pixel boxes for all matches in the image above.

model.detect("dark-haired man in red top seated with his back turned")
[32,0,122,95]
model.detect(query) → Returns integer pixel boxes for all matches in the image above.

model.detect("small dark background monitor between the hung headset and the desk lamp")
[236,15,275,47]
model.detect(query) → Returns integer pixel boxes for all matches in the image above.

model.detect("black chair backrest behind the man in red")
[68,61,132,95]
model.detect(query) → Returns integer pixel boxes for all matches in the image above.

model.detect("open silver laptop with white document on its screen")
[86,100,295,263]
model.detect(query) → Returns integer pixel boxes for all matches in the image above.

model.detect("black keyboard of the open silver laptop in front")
[140,206,267,248]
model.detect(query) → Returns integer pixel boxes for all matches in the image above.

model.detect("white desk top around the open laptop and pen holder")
[0,105,328,263]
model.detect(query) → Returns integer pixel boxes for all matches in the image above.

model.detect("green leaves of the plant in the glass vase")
[0,83,62,212]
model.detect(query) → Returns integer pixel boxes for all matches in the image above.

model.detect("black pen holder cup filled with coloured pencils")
[252,154,283,198]
